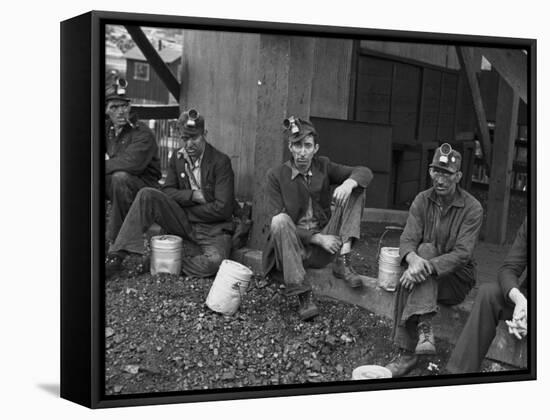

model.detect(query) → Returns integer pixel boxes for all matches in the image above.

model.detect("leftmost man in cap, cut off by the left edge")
[105,74,161,243]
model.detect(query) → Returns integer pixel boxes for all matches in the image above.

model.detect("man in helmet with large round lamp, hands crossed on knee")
[386,143,483,377]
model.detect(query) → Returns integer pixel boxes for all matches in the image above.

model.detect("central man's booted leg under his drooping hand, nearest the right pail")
[324,188,365,287]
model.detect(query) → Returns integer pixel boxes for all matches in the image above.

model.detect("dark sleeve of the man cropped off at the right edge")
[498,219,527,299]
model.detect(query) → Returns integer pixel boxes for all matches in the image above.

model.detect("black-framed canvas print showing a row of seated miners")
[61,11,536,408]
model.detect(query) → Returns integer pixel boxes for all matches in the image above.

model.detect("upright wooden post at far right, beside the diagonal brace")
[485,77,519,244]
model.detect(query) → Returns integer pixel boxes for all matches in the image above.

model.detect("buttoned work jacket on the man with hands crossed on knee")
[399,186,483,276]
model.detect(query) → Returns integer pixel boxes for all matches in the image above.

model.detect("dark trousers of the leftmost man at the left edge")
[105,171,156,242]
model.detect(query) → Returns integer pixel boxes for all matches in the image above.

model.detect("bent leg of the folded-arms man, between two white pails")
[182,224,231,278]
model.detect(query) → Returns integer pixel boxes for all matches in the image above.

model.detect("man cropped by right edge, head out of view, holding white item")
[447,220,528,373]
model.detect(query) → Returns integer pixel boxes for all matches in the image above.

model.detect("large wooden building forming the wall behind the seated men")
[128,29,527,246]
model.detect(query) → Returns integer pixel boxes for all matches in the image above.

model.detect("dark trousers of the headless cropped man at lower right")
[447,282,514,373]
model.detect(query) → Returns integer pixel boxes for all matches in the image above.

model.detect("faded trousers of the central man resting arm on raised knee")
[270,188,365,296]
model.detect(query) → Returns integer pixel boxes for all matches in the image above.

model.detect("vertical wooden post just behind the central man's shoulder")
[249,35,291,249]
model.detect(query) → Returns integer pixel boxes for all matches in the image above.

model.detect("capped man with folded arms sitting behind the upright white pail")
[106,109,235,278]
